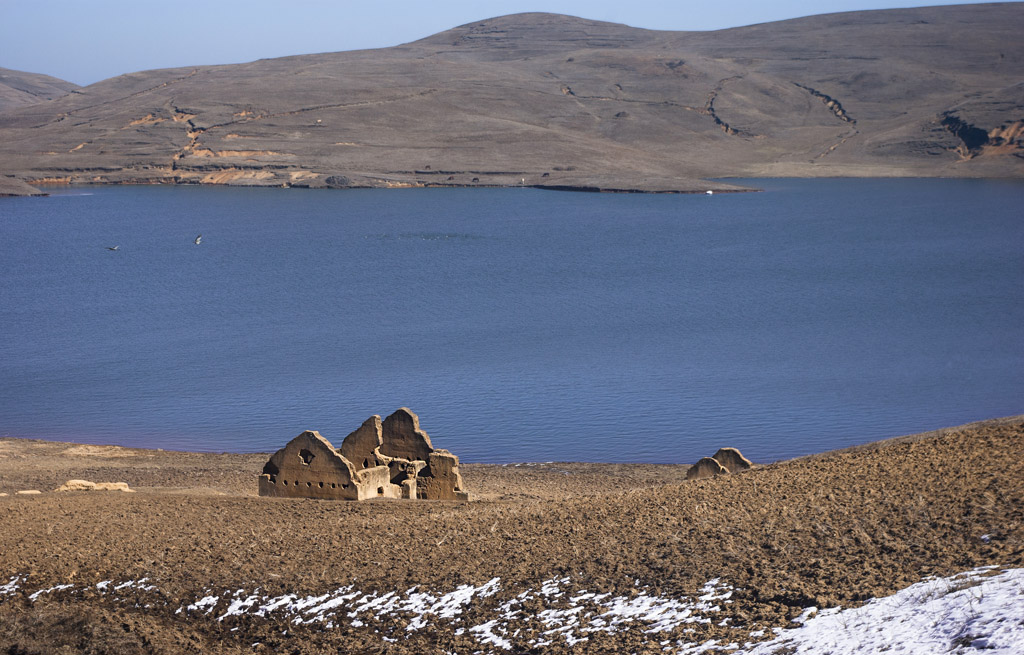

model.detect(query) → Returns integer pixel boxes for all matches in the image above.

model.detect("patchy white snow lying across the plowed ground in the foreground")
[0,567,1024,655]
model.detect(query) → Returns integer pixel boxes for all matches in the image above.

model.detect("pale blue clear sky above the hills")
[0,0,1007,85]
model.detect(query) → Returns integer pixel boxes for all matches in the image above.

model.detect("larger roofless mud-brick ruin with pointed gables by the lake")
[259,407,469,500]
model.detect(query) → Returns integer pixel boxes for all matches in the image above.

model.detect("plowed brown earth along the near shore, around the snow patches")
[0,417,1024,654]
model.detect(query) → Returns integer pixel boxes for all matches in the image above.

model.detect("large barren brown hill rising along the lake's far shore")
[0,3,1024,191]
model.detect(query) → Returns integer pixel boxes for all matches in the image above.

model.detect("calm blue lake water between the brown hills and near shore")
[0,180,1024,463]
